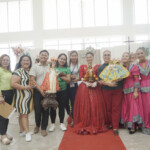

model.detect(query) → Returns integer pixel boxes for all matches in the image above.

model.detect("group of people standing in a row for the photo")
[0,47,150,144]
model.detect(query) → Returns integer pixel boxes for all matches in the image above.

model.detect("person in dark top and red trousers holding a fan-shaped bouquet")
[98,50,123,136]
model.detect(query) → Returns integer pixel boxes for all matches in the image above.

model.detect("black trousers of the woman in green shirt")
[50,90,67,123]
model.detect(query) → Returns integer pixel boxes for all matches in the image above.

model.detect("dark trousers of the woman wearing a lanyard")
[66,83,78,117]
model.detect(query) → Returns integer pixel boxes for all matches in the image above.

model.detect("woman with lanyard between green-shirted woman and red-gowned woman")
[67,51,80,127]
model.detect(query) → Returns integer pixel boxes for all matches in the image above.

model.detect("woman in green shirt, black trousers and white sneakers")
[49,53,70,131]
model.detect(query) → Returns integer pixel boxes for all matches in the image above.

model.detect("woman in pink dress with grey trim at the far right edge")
[136,47,150,135]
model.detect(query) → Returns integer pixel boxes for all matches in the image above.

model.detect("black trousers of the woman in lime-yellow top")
[0,90,13,135]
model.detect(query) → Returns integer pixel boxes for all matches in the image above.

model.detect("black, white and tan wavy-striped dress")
[13,68,33,114]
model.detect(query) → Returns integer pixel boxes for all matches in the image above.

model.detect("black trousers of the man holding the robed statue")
[33,89,49,130]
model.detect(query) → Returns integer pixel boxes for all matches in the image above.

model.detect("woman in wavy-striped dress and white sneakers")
[11,55,33,142]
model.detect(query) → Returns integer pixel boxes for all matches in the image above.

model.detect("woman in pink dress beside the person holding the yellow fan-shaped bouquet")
[121,52,143,134]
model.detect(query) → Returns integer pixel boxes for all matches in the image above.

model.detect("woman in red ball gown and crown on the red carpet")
[74,52,107,134]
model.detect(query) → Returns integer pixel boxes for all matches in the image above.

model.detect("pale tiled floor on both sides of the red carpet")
[0,113,150,150]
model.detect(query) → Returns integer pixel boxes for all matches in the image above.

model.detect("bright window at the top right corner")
[134,0,150,24]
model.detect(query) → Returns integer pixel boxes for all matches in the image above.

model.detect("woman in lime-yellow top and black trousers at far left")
[0,54,13,145]
